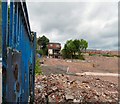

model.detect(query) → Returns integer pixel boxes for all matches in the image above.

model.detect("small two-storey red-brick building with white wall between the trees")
[48,43,61,58]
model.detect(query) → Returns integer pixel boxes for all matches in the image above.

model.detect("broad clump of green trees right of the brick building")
[62,39,88,60]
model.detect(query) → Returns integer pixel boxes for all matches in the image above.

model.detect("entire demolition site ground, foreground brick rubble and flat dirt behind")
[35,56,120,104]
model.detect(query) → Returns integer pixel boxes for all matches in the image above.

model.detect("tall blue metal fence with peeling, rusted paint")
[2,0,36,103]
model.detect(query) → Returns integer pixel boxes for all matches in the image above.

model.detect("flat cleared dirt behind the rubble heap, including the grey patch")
[42,56,118,84]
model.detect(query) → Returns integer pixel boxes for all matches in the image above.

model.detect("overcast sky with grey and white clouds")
[27,2,118,50]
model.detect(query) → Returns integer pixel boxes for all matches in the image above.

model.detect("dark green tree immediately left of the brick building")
[37,35,49,55]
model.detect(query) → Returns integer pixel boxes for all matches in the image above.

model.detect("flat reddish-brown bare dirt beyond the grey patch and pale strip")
[44,56,118,73]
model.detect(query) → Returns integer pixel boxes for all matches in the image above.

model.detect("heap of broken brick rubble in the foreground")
[35,74,118,104]
